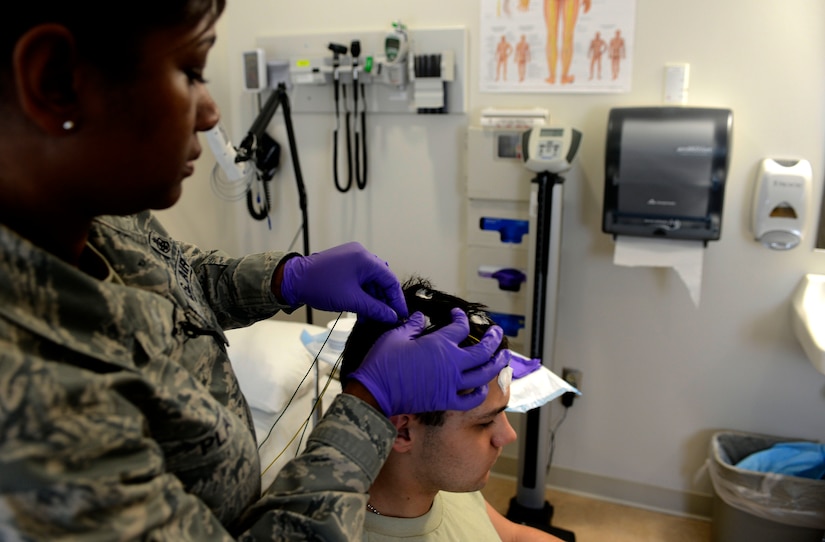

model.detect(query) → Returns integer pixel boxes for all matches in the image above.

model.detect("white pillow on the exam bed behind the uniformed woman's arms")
[226,320,324,414]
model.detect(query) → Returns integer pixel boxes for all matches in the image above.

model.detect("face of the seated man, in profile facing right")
[412,379,516,498]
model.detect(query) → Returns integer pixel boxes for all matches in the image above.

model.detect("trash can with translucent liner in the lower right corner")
[709,431,825,542]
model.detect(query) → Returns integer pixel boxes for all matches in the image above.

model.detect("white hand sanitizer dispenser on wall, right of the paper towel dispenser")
[753,158,813,250]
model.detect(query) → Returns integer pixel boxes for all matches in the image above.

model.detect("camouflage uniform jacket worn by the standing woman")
[0,213,395,541]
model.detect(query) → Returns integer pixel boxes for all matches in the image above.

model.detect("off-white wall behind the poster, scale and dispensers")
[163,0,825,520]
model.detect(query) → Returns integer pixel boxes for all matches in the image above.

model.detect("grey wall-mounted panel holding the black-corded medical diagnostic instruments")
[256,27,468,114]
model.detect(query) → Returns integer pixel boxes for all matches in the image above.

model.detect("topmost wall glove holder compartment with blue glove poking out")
[467,199,530,251]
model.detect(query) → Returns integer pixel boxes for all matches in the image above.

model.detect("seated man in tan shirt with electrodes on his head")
[341,278,561,542]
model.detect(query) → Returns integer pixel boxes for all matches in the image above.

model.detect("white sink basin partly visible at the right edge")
[791,274,825,373]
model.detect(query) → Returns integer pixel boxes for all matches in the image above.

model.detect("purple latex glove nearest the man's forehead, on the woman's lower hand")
[351,309,507,416]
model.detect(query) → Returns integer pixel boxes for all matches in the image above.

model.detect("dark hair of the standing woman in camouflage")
[0,0,226,88]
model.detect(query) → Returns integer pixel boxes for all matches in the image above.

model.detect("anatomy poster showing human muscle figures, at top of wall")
[479,0,636,93]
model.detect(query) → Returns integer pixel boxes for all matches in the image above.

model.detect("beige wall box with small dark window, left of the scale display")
[467,126,533,201]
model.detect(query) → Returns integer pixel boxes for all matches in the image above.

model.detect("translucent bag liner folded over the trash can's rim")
[708,431,825,529]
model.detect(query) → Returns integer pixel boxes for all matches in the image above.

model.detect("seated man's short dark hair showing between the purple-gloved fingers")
[341,277,509,425]
